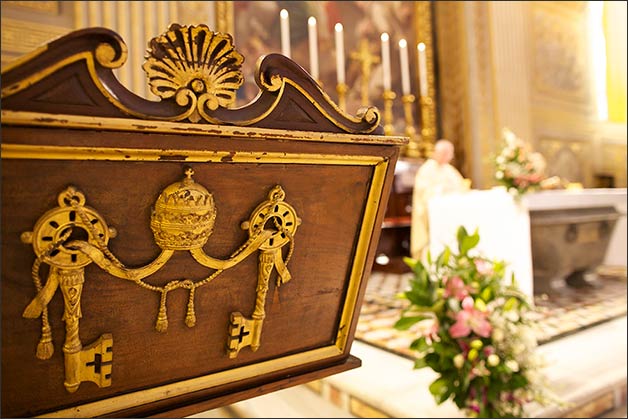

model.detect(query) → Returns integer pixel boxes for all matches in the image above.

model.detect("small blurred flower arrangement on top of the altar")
[494,128,546,196]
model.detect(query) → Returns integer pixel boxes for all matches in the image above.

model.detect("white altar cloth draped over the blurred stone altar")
[428,187,626,296]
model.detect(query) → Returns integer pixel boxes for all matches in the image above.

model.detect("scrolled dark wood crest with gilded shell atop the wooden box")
[2,24,383,134]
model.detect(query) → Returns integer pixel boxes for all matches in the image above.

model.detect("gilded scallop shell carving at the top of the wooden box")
[142,24,244,113]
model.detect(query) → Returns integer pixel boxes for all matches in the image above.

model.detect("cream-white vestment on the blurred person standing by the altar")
[410,159,468,259]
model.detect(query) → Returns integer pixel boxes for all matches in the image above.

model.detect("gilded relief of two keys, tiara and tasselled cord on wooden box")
[21,168,301,393]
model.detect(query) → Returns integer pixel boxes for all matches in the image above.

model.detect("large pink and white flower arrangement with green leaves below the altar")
[395,227,557,417]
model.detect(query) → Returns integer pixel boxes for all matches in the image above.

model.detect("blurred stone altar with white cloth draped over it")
[428,188,626,296]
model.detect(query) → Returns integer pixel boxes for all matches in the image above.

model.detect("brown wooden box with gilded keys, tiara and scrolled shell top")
[1,25,406,417]
